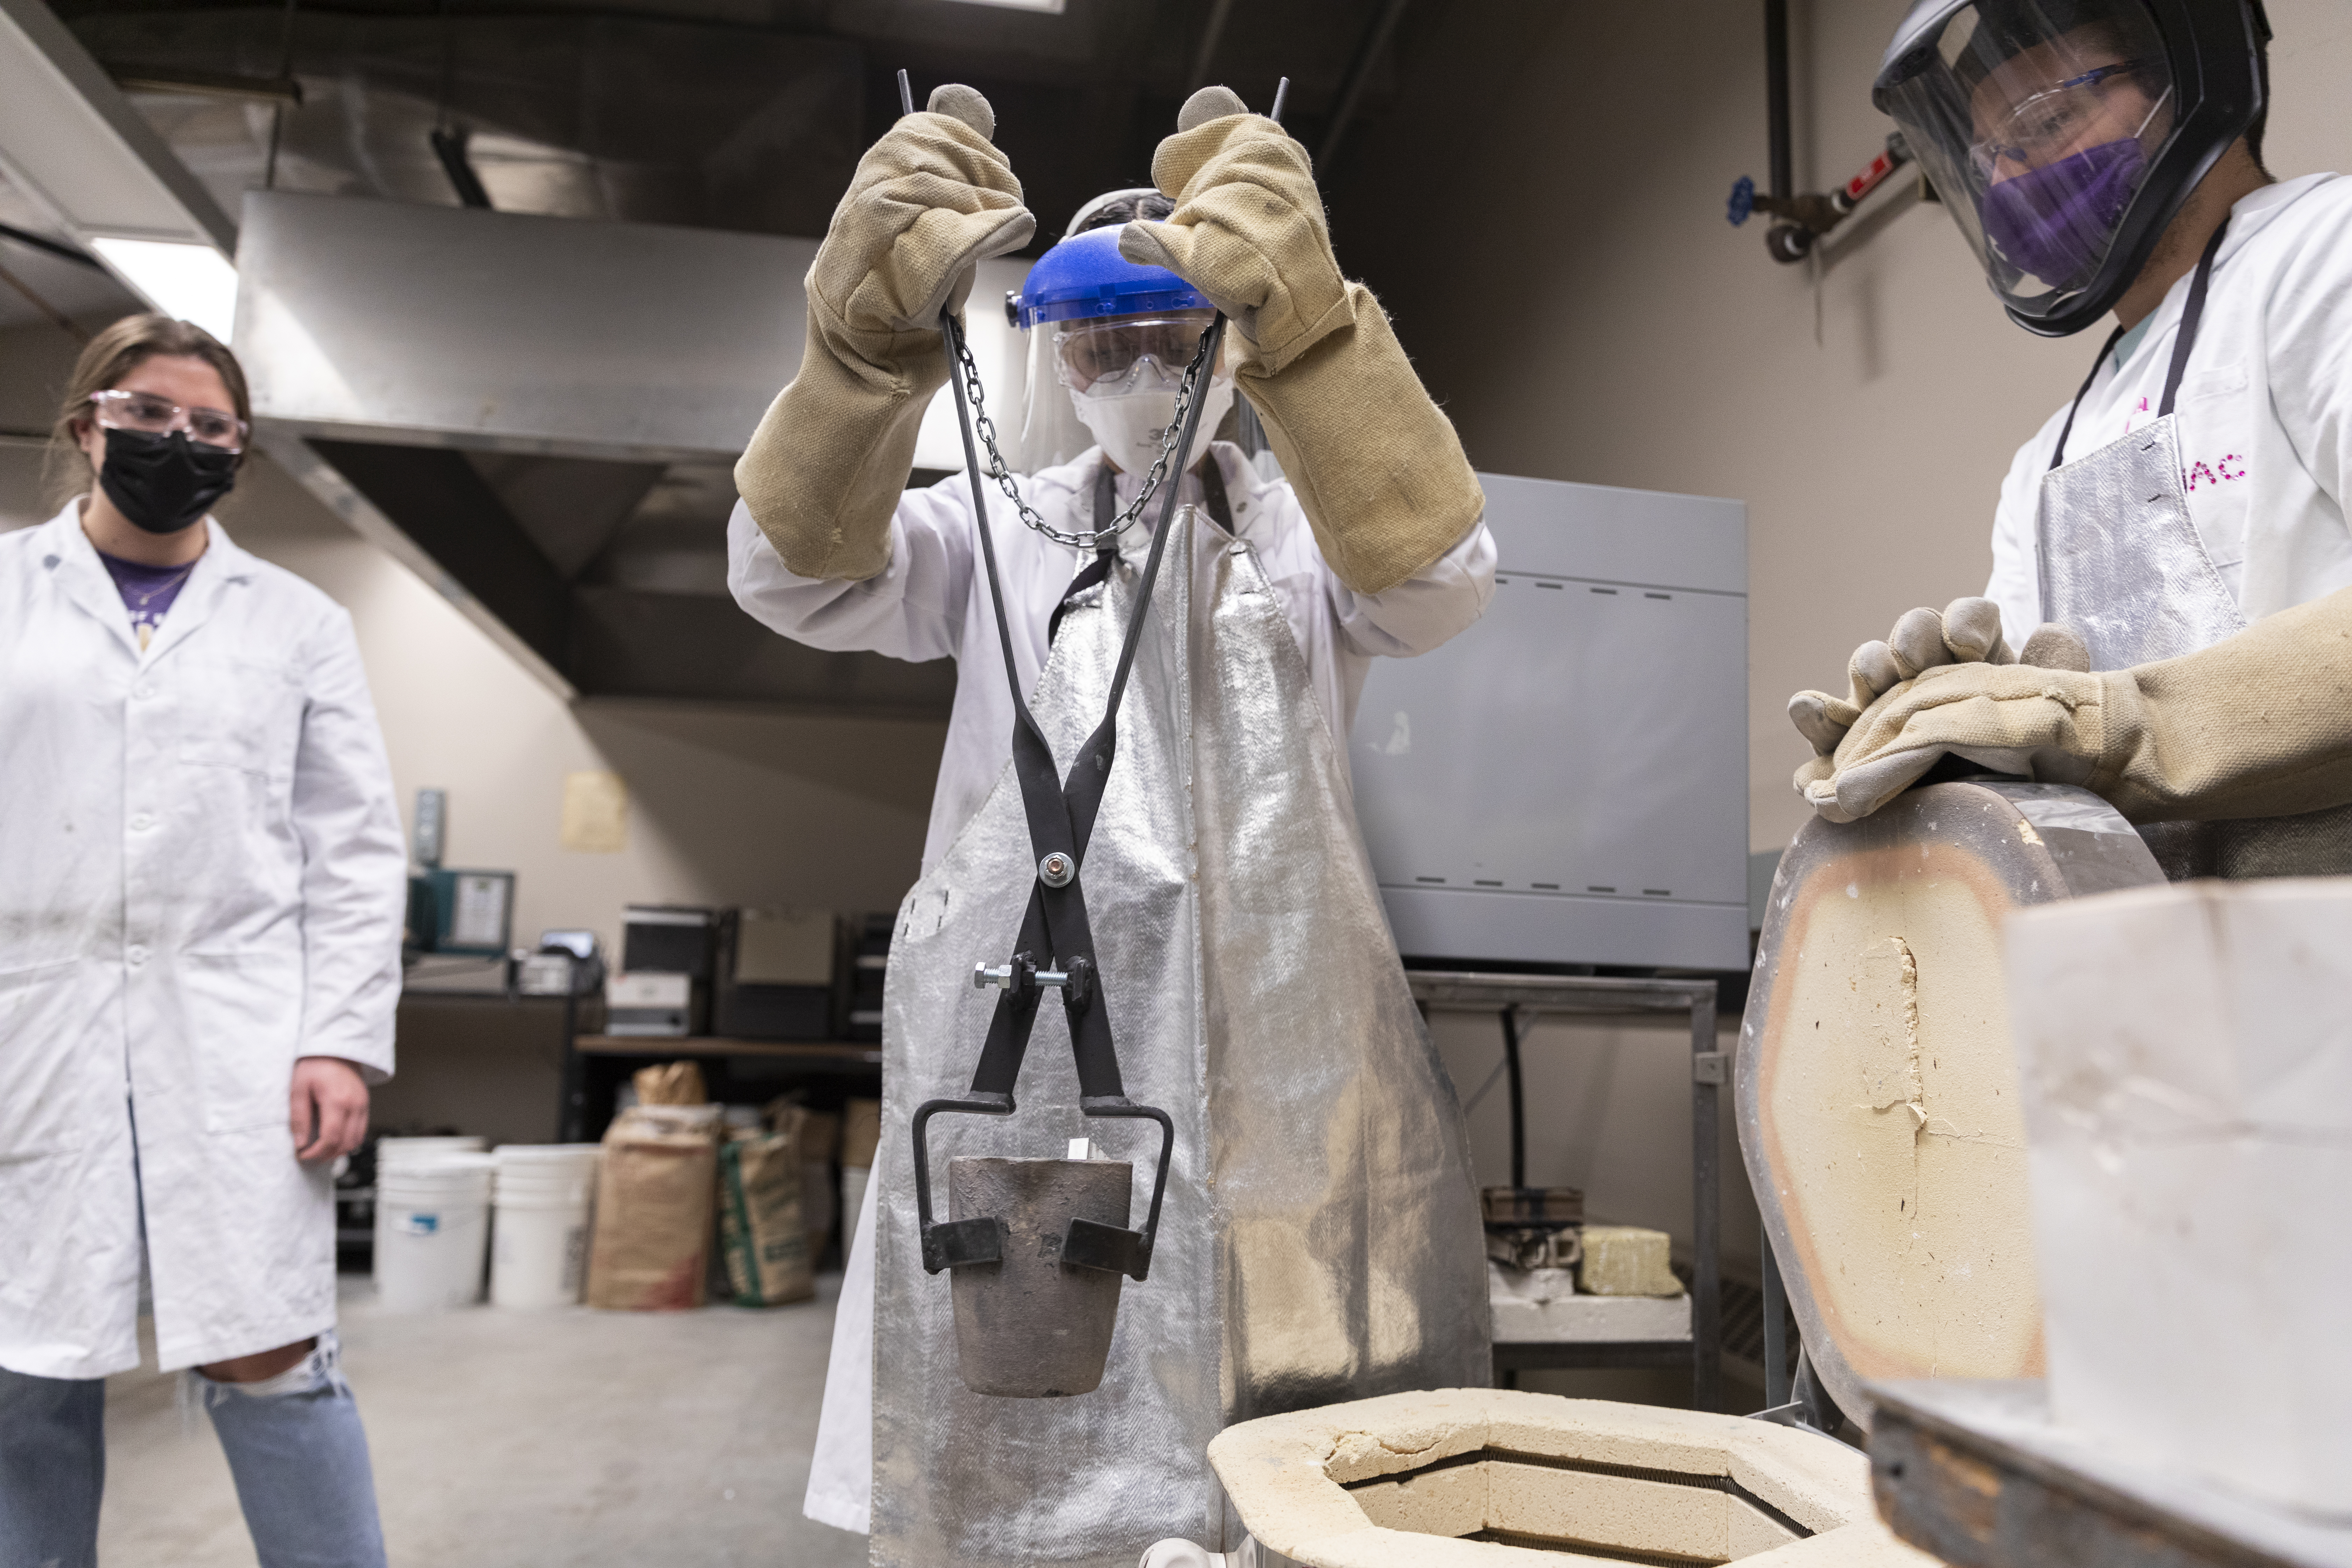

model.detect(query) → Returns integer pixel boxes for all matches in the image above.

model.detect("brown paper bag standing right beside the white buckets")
[588,1105,720,1312]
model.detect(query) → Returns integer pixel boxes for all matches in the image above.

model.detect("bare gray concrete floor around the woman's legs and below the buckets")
[99,1274,866,1568]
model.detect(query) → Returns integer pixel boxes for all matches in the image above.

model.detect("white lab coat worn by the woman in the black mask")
[0,503,407,1378]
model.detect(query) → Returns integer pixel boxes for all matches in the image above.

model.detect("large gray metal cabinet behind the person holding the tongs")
[1348,475,1748,968]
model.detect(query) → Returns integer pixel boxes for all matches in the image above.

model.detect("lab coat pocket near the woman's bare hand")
[179,950,301,1133]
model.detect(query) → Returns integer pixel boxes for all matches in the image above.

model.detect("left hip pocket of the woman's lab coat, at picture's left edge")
[0,959,102,1166]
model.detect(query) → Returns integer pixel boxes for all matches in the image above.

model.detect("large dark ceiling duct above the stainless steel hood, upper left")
[73,7,866,235]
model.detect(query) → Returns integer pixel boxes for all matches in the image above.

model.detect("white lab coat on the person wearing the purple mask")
[1985,174,2352,646]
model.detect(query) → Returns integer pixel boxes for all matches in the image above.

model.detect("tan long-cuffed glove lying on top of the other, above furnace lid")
[1799,588,2352,823]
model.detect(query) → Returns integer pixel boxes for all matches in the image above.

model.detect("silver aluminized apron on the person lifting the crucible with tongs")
[873,508,1491,1568]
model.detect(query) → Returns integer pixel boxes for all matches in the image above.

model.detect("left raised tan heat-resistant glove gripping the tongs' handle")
[736,85,1037,581]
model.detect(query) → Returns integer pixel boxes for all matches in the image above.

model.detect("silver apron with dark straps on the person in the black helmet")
[2035,223,2352,882]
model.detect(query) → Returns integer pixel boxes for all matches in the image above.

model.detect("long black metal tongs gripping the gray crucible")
[898,70,1279,1281]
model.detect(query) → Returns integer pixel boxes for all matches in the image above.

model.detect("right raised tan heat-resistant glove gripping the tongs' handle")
[1120,87,1486,593]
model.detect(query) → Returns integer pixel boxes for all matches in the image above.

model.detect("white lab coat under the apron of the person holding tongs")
[727,442,1496,1533]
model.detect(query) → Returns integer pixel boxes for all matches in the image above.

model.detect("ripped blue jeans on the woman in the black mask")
[0,1331,383,1568]
